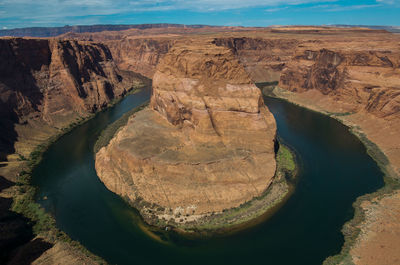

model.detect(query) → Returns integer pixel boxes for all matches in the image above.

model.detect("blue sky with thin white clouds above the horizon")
[0,0,400,29]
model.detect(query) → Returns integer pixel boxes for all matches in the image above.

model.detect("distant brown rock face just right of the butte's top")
[214,37,299,82]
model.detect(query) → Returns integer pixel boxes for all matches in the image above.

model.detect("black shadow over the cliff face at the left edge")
[0,39,47,161]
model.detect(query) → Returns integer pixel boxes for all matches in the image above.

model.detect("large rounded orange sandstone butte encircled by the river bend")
[96,41,276,224]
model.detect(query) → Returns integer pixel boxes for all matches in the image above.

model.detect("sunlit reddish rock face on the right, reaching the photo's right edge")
[279,47,400,119]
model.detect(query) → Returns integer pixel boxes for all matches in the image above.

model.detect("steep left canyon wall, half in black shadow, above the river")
[0,38,144,159]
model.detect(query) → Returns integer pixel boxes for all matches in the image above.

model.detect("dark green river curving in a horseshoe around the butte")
[34,90,383,265]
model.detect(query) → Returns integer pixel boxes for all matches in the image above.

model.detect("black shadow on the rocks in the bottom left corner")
[0,176,52,265]
